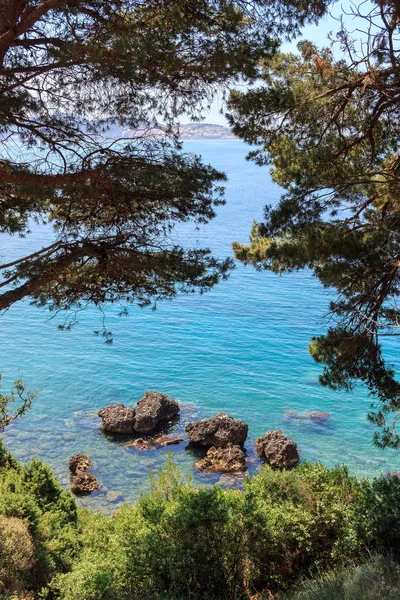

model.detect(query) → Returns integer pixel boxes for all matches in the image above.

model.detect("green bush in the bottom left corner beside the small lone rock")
[0,440,80,591]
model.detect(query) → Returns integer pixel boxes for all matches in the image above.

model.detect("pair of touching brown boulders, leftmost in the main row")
[98,391,179,435]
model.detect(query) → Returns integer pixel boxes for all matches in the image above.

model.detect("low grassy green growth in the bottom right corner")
[280,555,400,600]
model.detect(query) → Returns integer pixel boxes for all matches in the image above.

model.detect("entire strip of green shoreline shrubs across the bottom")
[0,446,400,600]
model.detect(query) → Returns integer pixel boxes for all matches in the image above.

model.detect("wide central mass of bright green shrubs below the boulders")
[53,463,372,600]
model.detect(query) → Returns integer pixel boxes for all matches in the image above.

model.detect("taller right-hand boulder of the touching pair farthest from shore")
[133,391,179,433]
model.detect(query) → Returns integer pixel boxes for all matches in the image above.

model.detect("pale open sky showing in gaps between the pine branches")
[188,0,367,125]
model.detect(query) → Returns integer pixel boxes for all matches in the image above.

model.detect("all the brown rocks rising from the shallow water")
[95,391,302,482]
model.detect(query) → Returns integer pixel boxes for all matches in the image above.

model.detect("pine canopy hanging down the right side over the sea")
[229,0,400,447]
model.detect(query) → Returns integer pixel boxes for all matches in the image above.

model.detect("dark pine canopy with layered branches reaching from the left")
[0,0,327,330]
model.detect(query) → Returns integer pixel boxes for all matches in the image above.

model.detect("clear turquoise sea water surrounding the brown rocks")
[0,140,400,510]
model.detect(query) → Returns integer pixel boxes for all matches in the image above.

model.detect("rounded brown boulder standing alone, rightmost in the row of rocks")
[256,429,300,469]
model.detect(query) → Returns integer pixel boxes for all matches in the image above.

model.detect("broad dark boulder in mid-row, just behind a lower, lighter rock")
[185,413,248,448]
